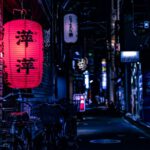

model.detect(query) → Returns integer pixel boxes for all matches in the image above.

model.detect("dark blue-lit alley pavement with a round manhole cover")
[77,106,150,150]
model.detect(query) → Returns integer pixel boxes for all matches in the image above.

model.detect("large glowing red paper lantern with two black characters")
[4,19,43,89]
